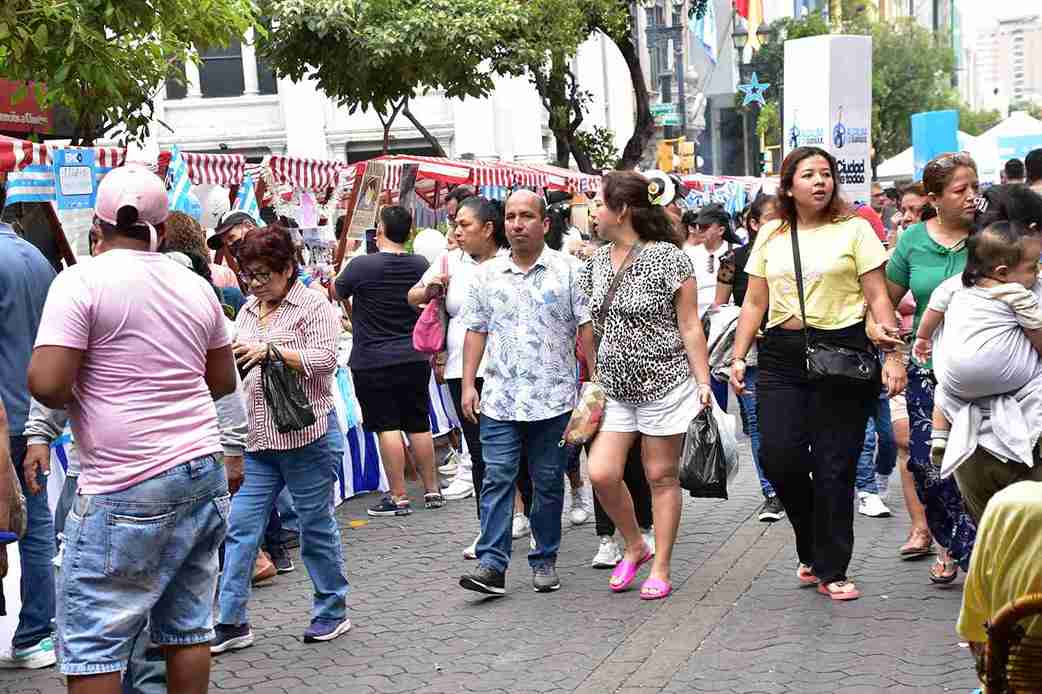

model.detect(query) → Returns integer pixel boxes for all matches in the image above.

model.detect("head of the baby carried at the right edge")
[963,222,1042,289]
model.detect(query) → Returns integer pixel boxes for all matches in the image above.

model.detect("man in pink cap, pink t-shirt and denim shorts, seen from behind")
[28,166,235,694]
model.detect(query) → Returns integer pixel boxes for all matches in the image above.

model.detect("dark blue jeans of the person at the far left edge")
[9,437,56,648]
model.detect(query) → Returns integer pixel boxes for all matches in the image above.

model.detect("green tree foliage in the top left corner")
[0,0,256,145]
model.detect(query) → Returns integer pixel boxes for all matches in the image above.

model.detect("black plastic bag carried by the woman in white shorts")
[679,400,738,499]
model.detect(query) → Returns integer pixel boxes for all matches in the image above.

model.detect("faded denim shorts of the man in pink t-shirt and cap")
[56,455,229,675]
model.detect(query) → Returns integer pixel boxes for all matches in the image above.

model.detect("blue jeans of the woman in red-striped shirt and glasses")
[217,425,348,625]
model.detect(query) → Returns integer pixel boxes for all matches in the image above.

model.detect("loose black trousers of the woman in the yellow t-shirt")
[758,323,880,583]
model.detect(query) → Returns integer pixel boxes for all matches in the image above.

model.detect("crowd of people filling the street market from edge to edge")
[0,147,1042,693]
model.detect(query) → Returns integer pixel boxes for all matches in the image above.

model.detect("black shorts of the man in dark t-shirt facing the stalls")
[351,362,430,433]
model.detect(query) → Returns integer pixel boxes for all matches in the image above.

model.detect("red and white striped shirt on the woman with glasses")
[235,281,340,452]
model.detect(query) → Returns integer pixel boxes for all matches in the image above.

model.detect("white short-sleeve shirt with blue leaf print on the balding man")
[464,248,590,422]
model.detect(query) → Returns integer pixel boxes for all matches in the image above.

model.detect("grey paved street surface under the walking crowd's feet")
[0,437,975,694]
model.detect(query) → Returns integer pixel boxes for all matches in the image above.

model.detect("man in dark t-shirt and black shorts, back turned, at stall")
[336,205,444,516]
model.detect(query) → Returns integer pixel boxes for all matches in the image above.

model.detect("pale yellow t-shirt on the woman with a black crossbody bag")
[745,217,887,330]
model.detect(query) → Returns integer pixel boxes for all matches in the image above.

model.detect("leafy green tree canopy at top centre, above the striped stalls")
[259,0,525,155]
